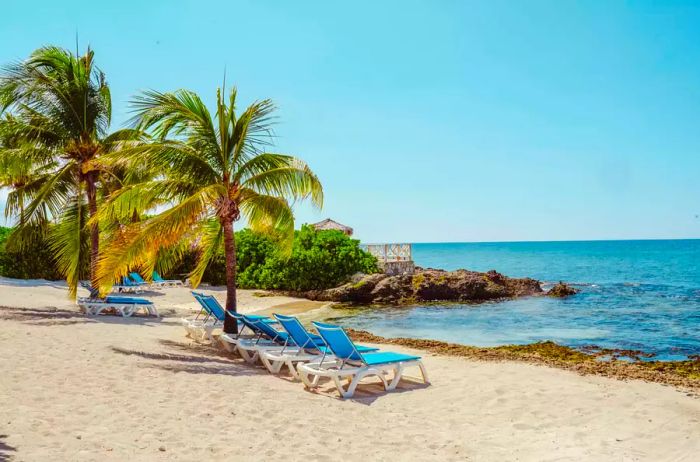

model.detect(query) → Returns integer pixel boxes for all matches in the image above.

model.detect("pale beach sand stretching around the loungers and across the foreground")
[0,280,700,461]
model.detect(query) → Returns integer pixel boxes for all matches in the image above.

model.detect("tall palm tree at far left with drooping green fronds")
[0,47,135,297]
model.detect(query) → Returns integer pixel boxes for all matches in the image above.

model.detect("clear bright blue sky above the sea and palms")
[0,0,700,242]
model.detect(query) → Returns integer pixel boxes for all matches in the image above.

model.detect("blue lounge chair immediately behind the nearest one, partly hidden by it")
[260,314,377,379]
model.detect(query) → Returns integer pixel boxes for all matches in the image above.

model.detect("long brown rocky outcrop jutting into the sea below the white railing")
[303,269,543,304]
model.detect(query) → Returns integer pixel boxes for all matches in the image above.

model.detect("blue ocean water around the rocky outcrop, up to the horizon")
[336,240,700,360]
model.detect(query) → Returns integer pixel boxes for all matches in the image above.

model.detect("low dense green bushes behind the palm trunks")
[0,225,378,291]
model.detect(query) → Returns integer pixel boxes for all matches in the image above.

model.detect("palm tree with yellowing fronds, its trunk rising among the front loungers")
[100,89,323,332]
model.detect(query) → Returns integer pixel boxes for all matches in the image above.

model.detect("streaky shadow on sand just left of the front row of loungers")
[111,339,263,376]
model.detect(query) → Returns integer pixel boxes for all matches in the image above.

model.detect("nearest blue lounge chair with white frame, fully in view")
[297,322,428,398]
